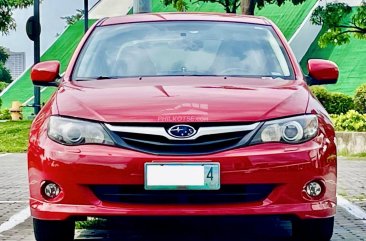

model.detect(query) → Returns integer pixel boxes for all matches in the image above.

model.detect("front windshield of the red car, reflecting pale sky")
[73,21,293,80]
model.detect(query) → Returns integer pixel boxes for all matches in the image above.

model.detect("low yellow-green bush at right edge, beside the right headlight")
[331,110,366,132]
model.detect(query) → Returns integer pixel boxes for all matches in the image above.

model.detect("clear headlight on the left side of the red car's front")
[48,116,114,145]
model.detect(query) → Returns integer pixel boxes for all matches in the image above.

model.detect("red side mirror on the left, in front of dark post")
[31,61,60,86]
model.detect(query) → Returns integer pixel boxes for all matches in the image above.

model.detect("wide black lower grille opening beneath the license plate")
[90,184,275,204]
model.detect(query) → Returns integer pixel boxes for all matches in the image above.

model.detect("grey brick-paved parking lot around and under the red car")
[0,154,366,241]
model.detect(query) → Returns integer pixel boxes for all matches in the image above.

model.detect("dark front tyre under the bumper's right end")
[292,217,334,241]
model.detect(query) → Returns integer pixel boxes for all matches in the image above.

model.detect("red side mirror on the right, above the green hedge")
[308,59,339,85]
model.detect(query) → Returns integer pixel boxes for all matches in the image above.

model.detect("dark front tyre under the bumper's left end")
[33,218,75,241]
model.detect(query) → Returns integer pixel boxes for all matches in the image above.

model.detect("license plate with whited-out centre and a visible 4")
[145,163,220,190]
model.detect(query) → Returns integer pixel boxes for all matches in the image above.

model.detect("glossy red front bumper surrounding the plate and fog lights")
[28,137,336,220]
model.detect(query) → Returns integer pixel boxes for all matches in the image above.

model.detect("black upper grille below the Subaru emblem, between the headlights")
[106,123,255,155]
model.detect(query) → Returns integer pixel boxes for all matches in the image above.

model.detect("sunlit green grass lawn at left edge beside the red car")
[0,121,31,153]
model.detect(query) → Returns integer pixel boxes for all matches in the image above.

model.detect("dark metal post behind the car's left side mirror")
[34,0,41,115]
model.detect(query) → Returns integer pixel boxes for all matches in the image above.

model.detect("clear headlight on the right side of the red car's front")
[251,115,318,144]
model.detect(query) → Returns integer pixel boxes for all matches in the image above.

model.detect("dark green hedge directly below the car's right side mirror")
[310,86,354,114]
